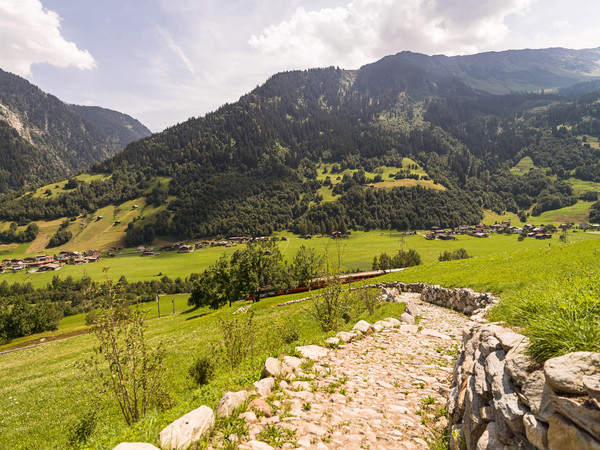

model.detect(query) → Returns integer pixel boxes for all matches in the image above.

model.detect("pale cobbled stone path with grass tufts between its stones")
[232,294,468,449]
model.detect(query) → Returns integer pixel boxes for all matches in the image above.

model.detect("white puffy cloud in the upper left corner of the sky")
[0,0,96,76]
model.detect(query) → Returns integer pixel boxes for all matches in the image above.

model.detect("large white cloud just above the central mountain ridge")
[249,0,534,68]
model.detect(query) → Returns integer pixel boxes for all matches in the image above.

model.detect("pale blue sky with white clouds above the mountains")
[0,0,600,132]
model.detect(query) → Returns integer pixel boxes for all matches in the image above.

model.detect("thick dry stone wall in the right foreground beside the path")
[448,322,600,449]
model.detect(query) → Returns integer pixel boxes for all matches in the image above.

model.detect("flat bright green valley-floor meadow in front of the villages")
[0,231,600,287]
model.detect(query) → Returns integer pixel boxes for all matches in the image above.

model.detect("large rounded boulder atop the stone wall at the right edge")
[544,352,600,395]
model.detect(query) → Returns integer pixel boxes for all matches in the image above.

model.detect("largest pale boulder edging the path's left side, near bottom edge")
[159,406,215,450]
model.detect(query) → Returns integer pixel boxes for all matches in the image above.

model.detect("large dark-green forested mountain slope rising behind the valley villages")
[0,49,600,245]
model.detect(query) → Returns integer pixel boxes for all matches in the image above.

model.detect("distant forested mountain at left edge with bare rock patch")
[0,69,150,192]
